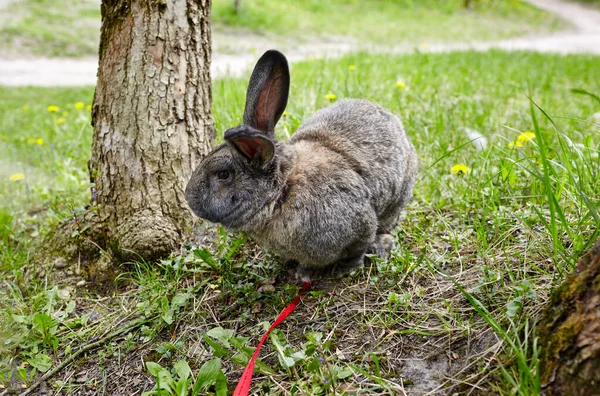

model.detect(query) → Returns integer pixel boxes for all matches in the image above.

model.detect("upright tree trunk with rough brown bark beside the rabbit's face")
[89,0,215,260]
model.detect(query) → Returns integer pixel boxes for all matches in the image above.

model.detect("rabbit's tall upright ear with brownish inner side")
[244,50,290,137]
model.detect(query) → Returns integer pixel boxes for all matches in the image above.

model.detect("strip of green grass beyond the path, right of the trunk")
[212,0,562,45]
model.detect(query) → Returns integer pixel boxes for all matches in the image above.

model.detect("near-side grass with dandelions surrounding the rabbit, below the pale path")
[0,52,600,395]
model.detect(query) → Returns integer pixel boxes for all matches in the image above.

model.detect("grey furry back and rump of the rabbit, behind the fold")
[290,99,417,233]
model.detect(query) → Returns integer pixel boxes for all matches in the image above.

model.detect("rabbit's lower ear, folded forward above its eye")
[225,125,275,167]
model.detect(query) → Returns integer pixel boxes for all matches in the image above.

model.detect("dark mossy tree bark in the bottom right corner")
[538,241,600,396]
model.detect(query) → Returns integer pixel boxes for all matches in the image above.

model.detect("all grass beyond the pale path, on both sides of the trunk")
[0,0,564,57]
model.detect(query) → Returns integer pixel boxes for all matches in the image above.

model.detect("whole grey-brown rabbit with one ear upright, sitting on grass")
[185,50,418,281]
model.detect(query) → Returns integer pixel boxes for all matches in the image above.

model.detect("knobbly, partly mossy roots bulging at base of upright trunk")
[34,207,182,284]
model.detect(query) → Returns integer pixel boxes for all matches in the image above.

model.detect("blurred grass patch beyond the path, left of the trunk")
[0,0,100,56]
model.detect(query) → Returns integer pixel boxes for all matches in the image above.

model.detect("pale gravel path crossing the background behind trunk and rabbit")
[0,0,600,86]
